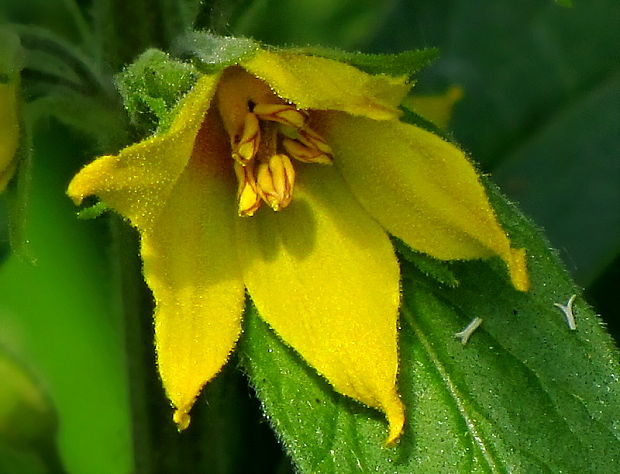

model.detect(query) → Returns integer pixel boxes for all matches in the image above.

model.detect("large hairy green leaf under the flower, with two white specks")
[240,183,620,473]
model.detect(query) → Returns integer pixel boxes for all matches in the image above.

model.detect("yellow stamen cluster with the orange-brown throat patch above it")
[216,67,333,217]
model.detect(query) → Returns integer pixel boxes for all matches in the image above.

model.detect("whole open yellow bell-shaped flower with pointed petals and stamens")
[68,50,528,442]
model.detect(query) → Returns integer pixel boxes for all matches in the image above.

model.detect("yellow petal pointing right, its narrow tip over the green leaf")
[315,113,529,291]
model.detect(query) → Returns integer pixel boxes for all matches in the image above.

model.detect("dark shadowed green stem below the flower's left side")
[111,220,202,474]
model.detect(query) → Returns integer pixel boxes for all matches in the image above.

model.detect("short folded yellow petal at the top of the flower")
[241,51,410,120]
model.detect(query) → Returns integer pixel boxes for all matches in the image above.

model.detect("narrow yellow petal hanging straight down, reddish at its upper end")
[147,113,244,429]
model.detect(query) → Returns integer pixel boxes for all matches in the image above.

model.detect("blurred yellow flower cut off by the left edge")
[0,79,19,192]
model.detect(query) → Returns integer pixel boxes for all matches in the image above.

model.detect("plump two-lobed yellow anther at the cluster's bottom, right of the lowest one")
[256,153,295,211]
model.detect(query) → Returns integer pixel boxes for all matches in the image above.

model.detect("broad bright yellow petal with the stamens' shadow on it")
[237,165,404,442]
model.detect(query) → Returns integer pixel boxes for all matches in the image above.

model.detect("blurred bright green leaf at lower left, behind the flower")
[0,122,133,473]
